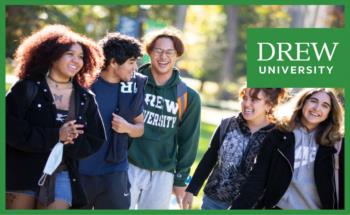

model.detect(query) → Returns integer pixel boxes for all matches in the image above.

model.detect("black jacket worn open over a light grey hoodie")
[231,130,344,209]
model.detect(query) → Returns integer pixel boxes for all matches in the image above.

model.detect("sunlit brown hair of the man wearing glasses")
[143,27,185,57]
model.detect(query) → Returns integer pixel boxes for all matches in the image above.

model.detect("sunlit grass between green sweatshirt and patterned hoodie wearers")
[191,122,216,209]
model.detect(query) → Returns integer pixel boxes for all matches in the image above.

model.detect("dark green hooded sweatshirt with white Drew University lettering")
[128,65,201,186]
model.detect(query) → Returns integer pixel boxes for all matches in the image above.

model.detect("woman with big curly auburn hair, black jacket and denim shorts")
[6,25,105,209]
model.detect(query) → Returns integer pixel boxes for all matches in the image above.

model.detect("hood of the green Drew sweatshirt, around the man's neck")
[138,63,180,88]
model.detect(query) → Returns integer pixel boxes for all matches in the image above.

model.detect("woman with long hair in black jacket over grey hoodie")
[231,88,344,209]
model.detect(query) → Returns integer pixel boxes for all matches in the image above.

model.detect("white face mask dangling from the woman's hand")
[38,142,63,186]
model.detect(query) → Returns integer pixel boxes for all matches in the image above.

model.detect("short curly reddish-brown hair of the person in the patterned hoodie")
[239,87,287,122]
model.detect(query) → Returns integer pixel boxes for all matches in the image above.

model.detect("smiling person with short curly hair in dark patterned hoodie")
[182,88,285,209]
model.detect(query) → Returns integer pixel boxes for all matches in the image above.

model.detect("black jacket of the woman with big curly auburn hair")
[6,76,105,208]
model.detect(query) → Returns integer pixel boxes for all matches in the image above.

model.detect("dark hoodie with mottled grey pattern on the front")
[186,113,274,204]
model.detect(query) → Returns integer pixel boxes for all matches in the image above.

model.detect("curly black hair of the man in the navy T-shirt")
[98,32,142,70]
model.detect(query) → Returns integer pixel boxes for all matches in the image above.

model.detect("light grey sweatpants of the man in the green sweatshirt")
[128,163,174,209]
